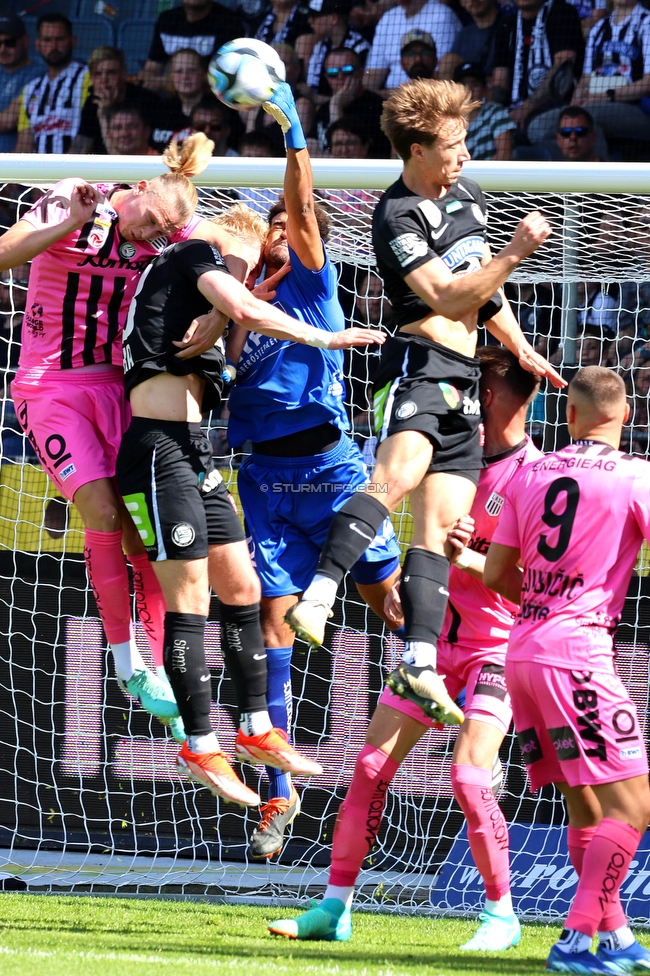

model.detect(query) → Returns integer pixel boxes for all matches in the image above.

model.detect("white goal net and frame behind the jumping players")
[0,156,650,921]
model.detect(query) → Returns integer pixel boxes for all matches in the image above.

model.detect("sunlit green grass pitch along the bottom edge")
[0,894,645,976]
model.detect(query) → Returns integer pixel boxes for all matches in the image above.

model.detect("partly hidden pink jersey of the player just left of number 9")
[441,438,543,659]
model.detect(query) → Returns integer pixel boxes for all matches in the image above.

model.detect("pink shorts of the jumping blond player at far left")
[11,369,131,501]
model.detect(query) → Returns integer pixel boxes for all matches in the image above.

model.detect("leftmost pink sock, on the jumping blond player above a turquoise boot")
[84,529,131,644]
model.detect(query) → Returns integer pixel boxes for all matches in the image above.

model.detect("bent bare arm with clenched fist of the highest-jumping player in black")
[404,211,551,321]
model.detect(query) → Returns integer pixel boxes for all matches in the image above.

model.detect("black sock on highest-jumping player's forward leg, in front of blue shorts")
[318,492,390,583]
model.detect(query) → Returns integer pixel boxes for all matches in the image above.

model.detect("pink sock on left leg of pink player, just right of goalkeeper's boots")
[329,745,399,887]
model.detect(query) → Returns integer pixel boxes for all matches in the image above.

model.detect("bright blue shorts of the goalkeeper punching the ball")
[238,434,400,597]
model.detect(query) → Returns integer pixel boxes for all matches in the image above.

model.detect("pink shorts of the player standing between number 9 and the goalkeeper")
[379,641,512,735]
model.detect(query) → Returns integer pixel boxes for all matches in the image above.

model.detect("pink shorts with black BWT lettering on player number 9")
[506,661,648,790]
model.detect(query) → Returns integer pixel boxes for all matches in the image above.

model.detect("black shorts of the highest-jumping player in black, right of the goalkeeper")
[374,335,484,484]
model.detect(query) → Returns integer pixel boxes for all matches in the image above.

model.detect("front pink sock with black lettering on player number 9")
[565,817,641,938]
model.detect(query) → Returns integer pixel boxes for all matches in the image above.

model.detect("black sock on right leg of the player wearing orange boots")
[221,603,268,714]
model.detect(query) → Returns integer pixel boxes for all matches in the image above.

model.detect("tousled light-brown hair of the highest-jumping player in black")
[381,78,481,162]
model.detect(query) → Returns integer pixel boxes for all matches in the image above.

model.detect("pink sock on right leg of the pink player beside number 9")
[451,763,510,901]
